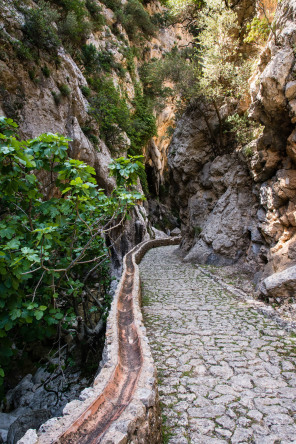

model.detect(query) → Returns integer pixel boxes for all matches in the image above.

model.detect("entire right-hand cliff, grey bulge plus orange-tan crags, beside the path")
[169,0,296,286]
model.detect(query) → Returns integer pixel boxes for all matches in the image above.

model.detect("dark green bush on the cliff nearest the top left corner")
[23,1,61,52]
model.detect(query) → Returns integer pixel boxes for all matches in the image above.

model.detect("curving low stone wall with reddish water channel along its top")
[18,237,180,444]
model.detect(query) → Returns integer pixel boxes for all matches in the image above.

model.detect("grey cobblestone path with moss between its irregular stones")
[140,246,296,444]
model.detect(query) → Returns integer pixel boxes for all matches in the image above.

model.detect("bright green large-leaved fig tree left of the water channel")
[0,117,142,386]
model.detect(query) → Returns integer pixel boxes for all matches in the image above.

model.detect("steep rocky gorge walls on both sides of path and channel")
[0,0,296,443]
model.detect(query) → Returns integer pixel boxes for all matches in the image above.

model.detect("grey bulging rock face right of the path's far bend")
[169,106,262,265]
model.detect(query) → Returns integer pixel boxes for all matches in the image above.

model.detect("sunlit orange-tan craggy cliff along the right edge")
[250,1,296,274]
